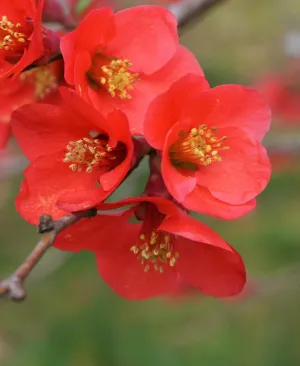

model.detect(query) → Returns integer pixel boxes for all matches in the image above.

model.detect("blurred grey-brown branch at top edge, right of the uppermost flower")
[169,0,226,30]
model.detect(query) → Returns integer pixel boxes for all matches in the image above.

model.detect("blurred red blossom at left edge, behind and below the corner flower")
[0,60,63,149]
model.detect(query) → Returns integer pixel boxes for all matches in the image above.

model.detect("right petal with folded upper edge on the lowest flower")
[160,213,246,297]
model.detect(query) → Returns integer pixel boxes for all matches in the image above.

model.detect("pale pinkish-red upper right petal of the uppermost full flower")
[104,5,178,75]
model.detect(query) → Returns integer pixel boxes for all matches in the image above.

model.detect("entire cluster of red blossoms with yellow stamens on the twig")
[0,0,270,299]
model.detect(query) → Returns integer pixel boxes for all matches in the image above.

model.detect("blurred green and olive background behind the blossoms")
[0,0,300,366]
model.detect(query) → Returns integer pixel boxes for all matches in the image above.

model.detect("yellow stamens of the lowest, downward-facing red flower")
[130,230,179,273]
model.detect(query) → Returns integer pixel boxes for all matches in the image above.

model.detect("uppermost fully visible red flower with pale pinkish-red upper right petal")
[61,6,203,134]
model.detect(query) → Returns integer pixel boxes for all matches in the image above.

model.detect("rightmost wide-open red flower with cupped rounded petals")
[145,75,270,219]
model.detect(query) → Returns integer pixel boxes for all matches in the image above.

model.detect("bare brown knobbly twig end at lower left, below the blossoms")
[0,209,97,301]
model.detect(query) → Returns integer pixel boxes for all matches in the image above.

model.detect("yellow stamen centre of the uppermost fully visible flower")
[87,55,139,99]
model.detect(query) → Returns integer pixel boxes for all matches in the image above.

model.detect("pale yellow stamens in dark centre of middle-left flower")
[63,137,125,173]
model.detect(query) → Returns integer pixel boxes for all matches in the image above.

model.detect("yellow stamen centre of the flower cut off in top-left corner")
[0,15,29,53]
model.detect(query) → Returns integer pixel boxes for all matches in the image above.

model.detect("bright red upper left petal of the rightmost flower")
[144,73,209,150]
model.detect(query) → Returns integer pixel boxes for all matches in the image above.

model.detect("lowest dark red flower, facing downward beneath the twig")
[55,197,246,299]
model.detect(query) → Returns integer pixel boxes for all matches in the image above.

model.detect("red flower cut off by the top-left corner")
[0,0,44,79]
